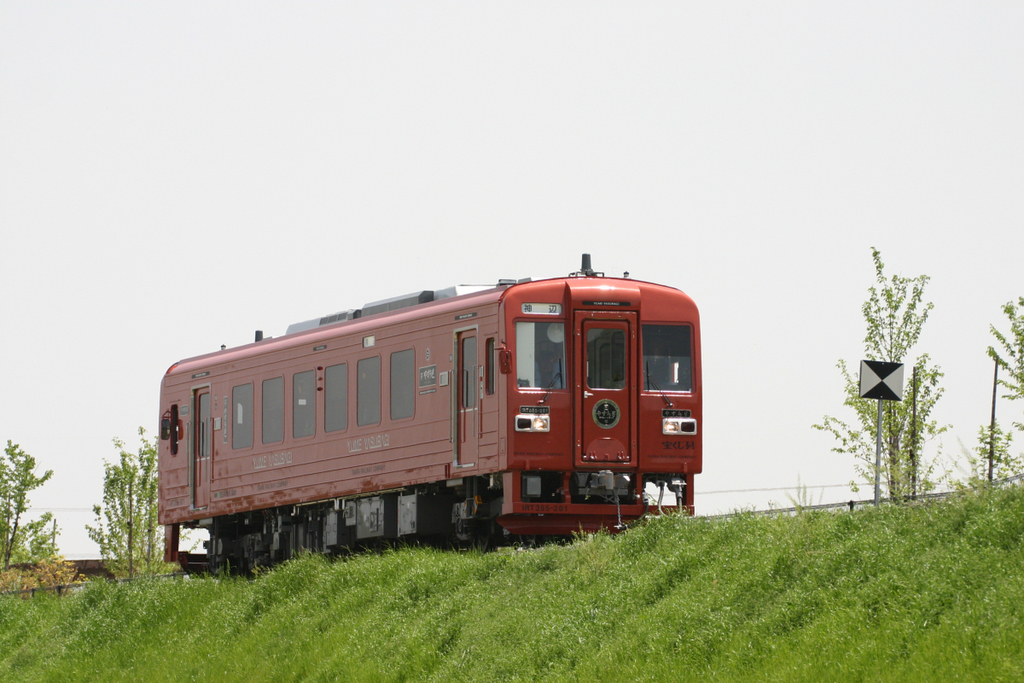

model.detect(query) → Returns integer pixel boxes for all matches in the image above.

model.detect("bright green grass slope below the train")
[0,488,1024,683]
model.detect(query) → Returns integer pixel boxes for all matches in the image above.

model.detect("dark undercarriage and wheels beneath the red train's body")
[167,470,686,573]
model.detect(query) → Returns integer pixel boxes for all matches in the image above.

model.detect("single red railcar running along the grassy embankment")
[160,255,701,570]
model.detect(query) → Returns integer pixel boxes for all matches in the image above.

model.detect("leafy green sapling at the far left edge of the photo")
[0,440,56,571]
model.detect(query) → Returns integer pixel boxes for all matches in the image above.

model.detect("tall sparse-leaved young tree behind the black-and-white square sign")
[814,247,946,500]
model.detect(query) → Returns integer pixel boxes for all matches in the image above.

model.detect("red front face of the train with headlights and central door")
[498,270,701,535]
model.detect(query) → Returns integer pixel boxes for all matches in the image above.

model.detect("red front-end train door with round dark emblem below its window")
[574,311,636,466]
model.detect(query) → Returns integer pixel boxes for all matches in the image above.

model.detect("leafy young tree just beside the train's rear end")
[85,427,164,578]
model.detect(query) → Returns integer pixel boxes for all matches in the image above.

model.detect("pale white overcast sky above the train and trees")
[0,0,1024,557]
